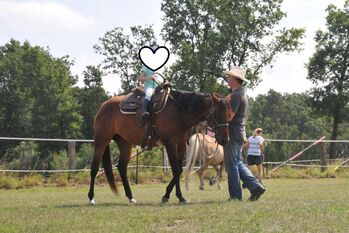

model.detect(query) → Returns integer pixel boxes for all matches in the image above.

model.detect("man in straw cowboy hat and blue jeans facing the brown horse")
[223,67,265,201]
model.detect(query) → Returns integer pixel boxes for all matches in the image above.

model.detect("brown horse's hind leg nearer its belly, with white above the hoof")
[113,136,136,203]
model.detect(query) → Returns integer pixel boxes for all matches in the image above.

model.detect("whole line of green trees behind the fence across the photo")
[0,0,349,168]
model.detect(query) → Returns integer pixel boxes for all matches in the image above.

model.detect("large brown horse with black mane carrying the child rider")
[88,87,232,204]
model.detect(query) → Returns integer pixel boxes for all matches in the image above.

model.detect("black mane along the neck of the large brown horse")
[171,90,210,112]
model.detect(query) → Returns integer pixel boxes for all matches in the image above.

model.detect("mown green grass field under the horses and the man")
[0,178,349,232]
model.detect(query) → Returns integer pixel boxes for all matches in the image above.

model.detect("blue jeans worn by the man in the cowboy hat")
[223,140,262,200]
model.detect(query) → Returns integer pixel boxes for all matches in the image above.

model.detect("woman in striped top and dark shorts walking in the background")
[243,128,264,183]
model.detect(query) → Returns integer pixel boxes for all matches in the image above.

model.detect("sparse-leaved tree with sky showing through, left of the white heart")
[94,25,156,93]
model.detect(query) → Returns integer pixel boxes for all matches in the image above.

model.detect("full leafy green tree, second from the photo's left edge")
[28,51,82,141]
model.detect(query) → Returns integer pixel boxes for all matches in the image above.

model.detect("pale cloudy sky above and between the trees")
[0,0,344,97]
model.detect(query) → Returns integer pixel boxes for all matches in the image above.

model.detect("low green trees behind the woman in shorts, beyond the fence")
[246,90,329,161]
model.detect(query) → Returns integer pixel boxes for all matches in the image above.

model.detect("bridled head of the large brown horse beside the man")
[207,94,229,146]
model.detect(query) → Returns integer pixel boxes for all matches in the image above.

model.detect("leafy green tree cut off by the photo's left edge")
[0,40,34,136]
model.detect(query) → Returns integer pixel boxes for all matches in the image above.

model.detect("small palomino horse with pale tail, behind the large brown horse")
[185,133,224,190]
